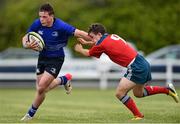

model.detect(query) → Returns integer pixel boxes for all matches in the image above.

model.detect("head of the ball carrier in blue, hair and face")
[39,3,54,27]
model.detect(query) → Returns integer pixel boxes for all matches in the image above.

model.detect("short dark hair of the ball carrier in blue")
[39,3,54,15]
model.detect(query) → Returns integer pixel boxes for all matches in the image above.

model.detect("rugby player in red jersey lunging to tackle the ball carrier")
[75,23,179,120]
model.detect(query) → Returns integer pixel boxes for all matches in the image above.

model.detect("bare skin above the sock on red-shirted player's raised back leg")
[133,84,145,97]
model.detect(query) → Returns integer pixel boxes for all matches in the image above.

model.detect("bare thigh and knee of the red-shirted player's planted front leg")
[116,77,136,97]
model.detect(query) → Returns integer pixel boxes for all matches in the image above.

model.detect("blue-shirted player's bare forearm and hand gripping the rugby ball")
[22,34,38,50]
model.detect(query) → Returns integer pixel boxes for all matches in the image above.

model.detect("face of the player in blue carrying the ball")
[39,11,54,27]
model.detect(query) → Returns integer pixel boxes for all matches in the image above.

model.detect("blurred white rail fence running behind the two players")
[0,59,180,89]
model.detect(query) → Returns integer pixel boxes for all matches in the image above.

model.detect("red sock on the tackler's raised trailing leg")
[143,86,169,97]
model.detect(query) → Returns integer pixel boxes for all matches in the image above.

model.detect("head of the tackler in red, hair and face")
[88,23,106,42]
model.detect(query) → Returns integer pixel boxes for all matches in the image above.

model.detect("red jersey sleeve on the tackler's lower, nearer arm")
[89,46,104,58]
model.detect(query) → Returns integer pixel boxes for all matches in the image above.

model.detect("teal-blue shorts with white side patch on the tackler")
[124,55,152,84]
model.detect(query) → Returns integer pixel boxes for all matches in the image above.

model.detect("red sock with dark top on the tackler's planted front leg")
[120,95,144,118]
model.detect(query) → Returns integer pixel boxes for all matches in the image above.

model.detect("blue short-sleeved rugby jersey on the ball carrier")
[27,18,76,57]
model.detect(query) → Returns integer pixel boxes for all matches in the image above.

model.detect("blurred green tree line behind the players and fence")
[0,0,180,54]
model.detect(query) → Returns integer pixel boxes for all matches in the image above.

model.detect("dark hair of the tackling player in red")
[88,23,106,35]
